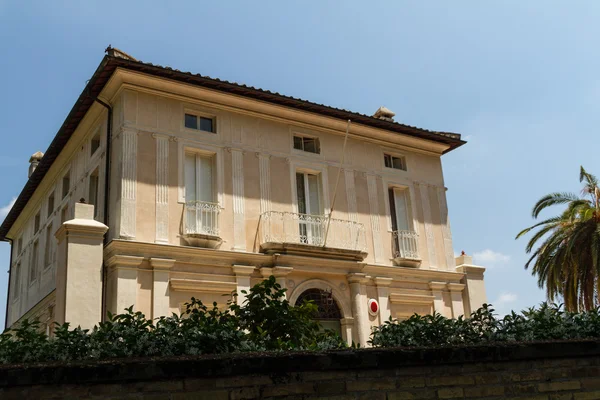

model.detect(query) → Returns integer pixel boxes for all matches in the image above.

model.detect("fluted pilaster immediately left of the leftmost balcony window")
[152,133,169,243]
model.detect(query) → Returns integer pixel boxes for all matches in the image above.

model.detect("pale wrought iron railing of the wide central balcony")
[259,211,367,252]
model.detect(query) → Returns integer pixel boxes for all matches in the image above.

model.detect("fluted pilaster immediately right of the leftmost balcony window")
[231,149,246,251]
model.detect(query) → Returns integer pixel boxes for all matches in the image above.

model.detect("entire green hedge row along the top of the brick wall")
[0,277,600,363]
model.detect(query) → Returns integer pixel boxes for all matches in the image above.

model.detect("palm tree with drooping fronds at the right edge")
[517,167,600,311]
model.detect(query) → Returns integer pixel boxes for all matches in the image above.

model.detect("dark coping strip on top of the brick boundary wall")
[0,340,600,388]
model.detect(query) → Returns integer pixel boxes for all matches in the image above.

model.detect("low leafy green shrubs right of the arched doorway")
[370,303,600,347]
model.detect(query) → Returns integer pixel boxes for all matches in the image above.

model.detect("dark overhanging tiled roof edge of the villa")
[0,48,465,240]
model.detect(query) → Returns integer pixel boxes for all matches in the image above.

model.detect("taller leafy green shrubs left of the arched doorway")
[0,277,346,363]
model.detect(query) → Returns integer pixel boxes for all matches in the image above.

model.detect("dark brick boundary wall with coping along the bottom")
[0,341,600,400]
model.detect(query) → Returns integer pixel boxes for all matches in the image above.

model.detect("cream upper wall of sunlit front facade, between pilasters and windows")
[115,89,454,270]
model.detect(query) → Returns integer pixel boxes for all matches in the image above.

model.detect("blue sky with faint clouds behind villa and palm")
[0,0,600,327]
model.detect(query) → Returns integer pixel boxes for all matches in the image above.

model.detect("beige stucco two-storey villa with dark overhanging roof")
[0,49,486,345]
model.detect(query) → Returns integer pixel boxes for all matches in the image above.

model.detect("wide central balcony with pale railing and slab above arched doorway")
[258,211,367,261]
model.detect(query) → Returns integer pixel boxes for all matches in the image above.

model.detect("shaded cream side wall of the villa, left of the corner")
[7,108,106,326]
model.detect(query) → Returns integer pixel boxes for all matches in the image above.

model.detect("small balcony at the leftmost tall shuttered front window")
[183,201,222,249]
